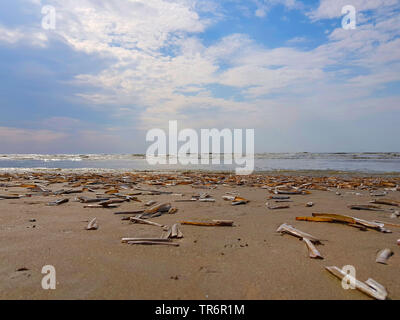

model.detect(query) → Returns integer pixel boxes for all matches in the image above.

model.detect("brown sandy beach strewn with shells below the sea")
[0,171,400,300]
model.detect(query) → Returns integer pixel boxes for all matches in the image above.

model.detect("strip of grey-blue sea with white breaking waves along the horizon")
[0,152,400,173]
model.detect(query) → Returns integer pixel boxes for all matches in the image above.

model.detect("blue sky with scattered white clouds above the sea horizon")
[0,0,400,154]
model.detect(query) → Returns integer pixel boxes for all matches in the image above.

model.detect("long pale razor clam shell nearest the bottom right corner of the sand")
[325,266,388,300]
